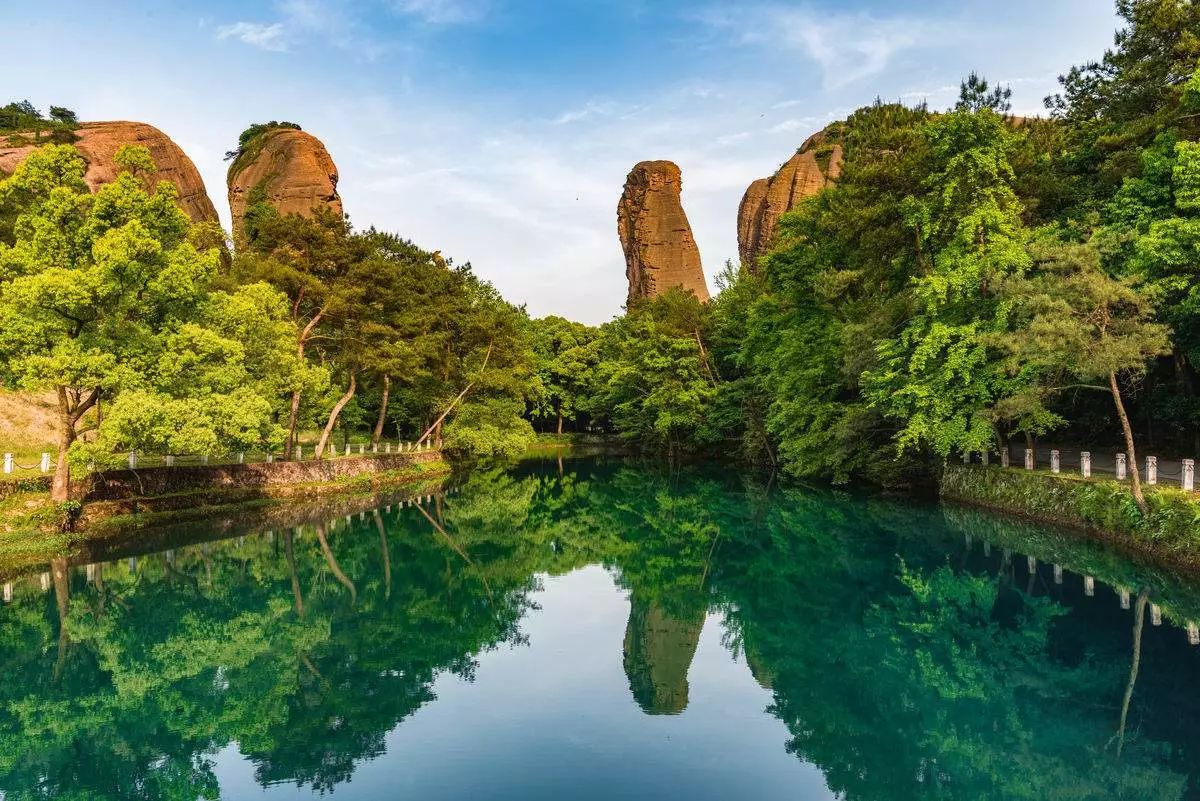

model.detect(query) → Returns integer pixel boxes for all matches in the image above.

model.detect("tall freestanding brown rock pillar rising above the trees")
[617,161,708,302]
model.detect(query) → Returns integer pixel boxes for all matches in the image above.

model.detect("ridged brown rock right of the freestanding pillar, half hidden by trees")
[738,131,841,269]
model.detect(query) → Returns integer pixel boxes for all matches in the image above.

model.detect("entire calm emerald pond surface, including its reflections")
[0,460,1200,801]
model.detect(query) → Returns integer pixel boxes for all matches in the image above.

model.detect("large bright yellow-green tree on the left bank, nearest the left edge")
[0,145,288,501]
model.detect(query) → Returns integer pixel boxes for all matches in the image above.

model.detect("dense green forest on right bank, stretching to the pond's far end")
[535,0,1200,496]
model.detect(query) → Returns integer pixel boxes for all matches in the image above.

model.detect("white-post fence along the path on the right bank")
[962,442,1195,492]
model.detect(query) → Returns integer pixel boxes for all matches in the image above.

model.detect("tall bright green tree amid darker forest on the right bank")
[864,108,1028,457]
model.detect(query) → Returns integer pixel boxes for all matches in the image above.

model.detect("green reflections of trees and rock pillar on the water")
[0,463,1196,801]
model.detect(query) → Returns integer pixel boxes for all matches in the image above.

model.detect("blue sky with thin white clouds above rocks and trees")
[0,0,1117,323]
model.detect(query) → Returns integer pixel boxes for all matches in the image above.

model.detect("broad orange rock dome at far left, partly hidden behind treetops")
[0,121,217,222]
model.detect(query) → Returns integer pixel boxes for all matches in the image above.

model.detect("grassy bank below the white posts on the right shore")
[940,464,1200,572]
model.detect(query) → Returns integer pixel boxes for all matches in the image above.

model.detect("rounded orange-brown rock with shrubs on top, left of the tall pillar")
[228,128,342,237]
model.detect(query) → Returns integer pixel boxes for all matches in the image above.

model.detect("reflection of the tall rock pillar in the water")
[624,595,704,715]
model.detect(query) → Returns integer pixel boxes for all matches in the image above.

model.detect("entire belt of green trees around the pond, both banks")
[0,0,1200,502]
